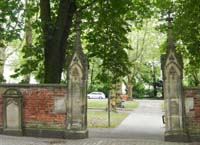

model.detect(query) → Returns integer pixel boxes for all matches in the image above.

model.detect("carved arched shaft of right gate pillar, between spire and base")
[163,51,184,132]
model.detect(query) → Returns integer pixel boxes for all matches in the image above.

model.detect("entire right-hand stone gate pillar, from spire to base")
[162,13,187,141]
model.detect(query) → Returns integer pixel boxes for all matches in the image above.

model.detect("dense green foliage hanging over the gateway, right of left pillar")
[83,0,155,93]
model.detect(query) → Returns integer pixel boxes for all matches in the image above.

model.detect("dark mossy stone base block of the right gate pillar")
[164,131,190,142]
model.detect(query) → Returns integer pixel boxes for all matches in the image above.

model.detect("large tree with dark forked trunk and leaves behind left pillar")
[7,0,155,83]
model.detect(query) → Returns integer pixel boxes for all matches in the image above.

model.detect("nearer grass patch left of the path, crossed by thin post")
[88,111,128,128]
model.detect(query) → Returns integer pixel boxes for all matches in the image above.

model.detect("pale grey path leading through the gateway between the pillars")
[89,100,164,140]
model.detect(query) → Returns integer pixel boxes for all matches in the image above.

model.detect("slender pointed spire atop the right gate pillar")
[166,11,175,51]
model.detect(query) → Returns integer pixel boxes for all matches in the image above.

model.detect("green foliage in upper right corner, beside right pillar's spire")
[174,0,200,65]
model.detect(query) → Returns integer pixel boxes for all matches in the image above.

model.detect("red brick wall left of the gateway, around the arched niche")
[0,85,67,128]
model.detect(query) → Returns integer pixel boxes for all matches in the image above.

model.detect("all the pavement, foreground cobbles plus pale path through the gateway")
[0,100,197,145]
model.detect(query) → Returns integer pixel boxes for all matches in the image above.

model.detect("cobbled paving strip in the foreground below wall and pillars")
[0,135,191,145]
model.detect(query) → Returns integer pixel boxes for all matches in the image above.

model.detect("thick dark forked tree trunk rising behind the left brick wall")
[40,0,76,83]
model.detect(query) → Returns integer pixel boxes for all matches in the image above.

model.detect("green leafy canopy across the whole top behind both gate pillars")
[0,0,200,88]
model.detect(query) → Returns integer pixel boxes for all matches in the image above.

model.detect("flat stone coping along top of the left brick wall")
[0,83,67,88]
